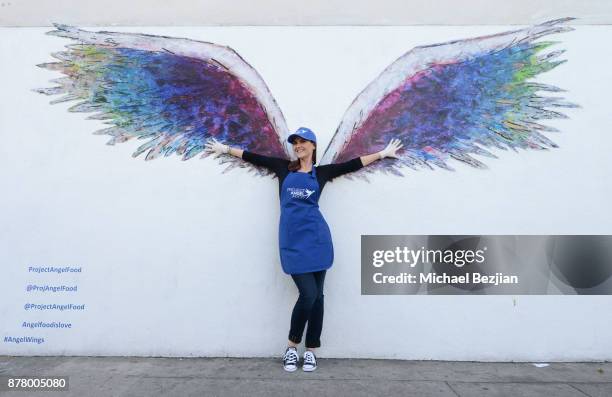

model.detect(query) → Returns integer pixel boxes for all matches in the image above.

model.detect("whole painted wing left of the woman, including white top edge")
[35,24,290,175]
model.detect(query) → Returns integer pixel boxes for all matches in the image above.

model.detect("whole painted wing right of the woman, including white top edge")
[321,18,578,180]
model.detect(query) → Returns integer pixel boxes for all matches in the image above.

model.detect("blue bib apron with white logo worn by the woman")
[278,165,334,274]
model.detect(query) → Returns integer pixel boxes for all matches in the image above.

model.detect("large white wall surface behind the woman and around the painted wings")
[0,26,612,361]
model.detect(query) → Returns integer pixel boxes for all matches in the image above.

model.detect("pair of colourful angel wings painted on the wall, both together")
[36,18,578,180]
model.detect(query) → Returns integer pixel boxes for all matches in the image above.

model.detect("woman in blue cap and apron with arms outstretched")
[206,127,401,372]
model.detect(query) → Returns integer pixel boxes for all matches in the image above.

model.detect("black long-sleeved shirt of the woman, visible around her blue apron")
[242,150,363,197]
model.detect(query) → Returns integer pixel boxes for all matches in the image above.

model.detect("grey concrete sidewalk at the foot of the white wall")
[0,356,612,397]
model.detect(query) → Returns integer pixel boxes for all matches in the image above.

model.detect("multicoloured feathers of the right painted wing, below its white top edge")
[334,37,576,169]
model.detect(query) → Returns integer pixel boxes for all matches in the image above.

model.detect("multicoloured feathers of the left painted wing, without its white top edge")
[37,44,285,160]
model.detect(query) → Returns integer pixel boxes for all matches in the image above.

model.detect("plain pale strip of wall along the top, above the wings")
[0,0,612,26]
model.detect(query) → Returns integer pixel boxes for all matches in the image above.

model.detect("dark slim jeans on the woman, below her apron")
[289,270,327,348]
